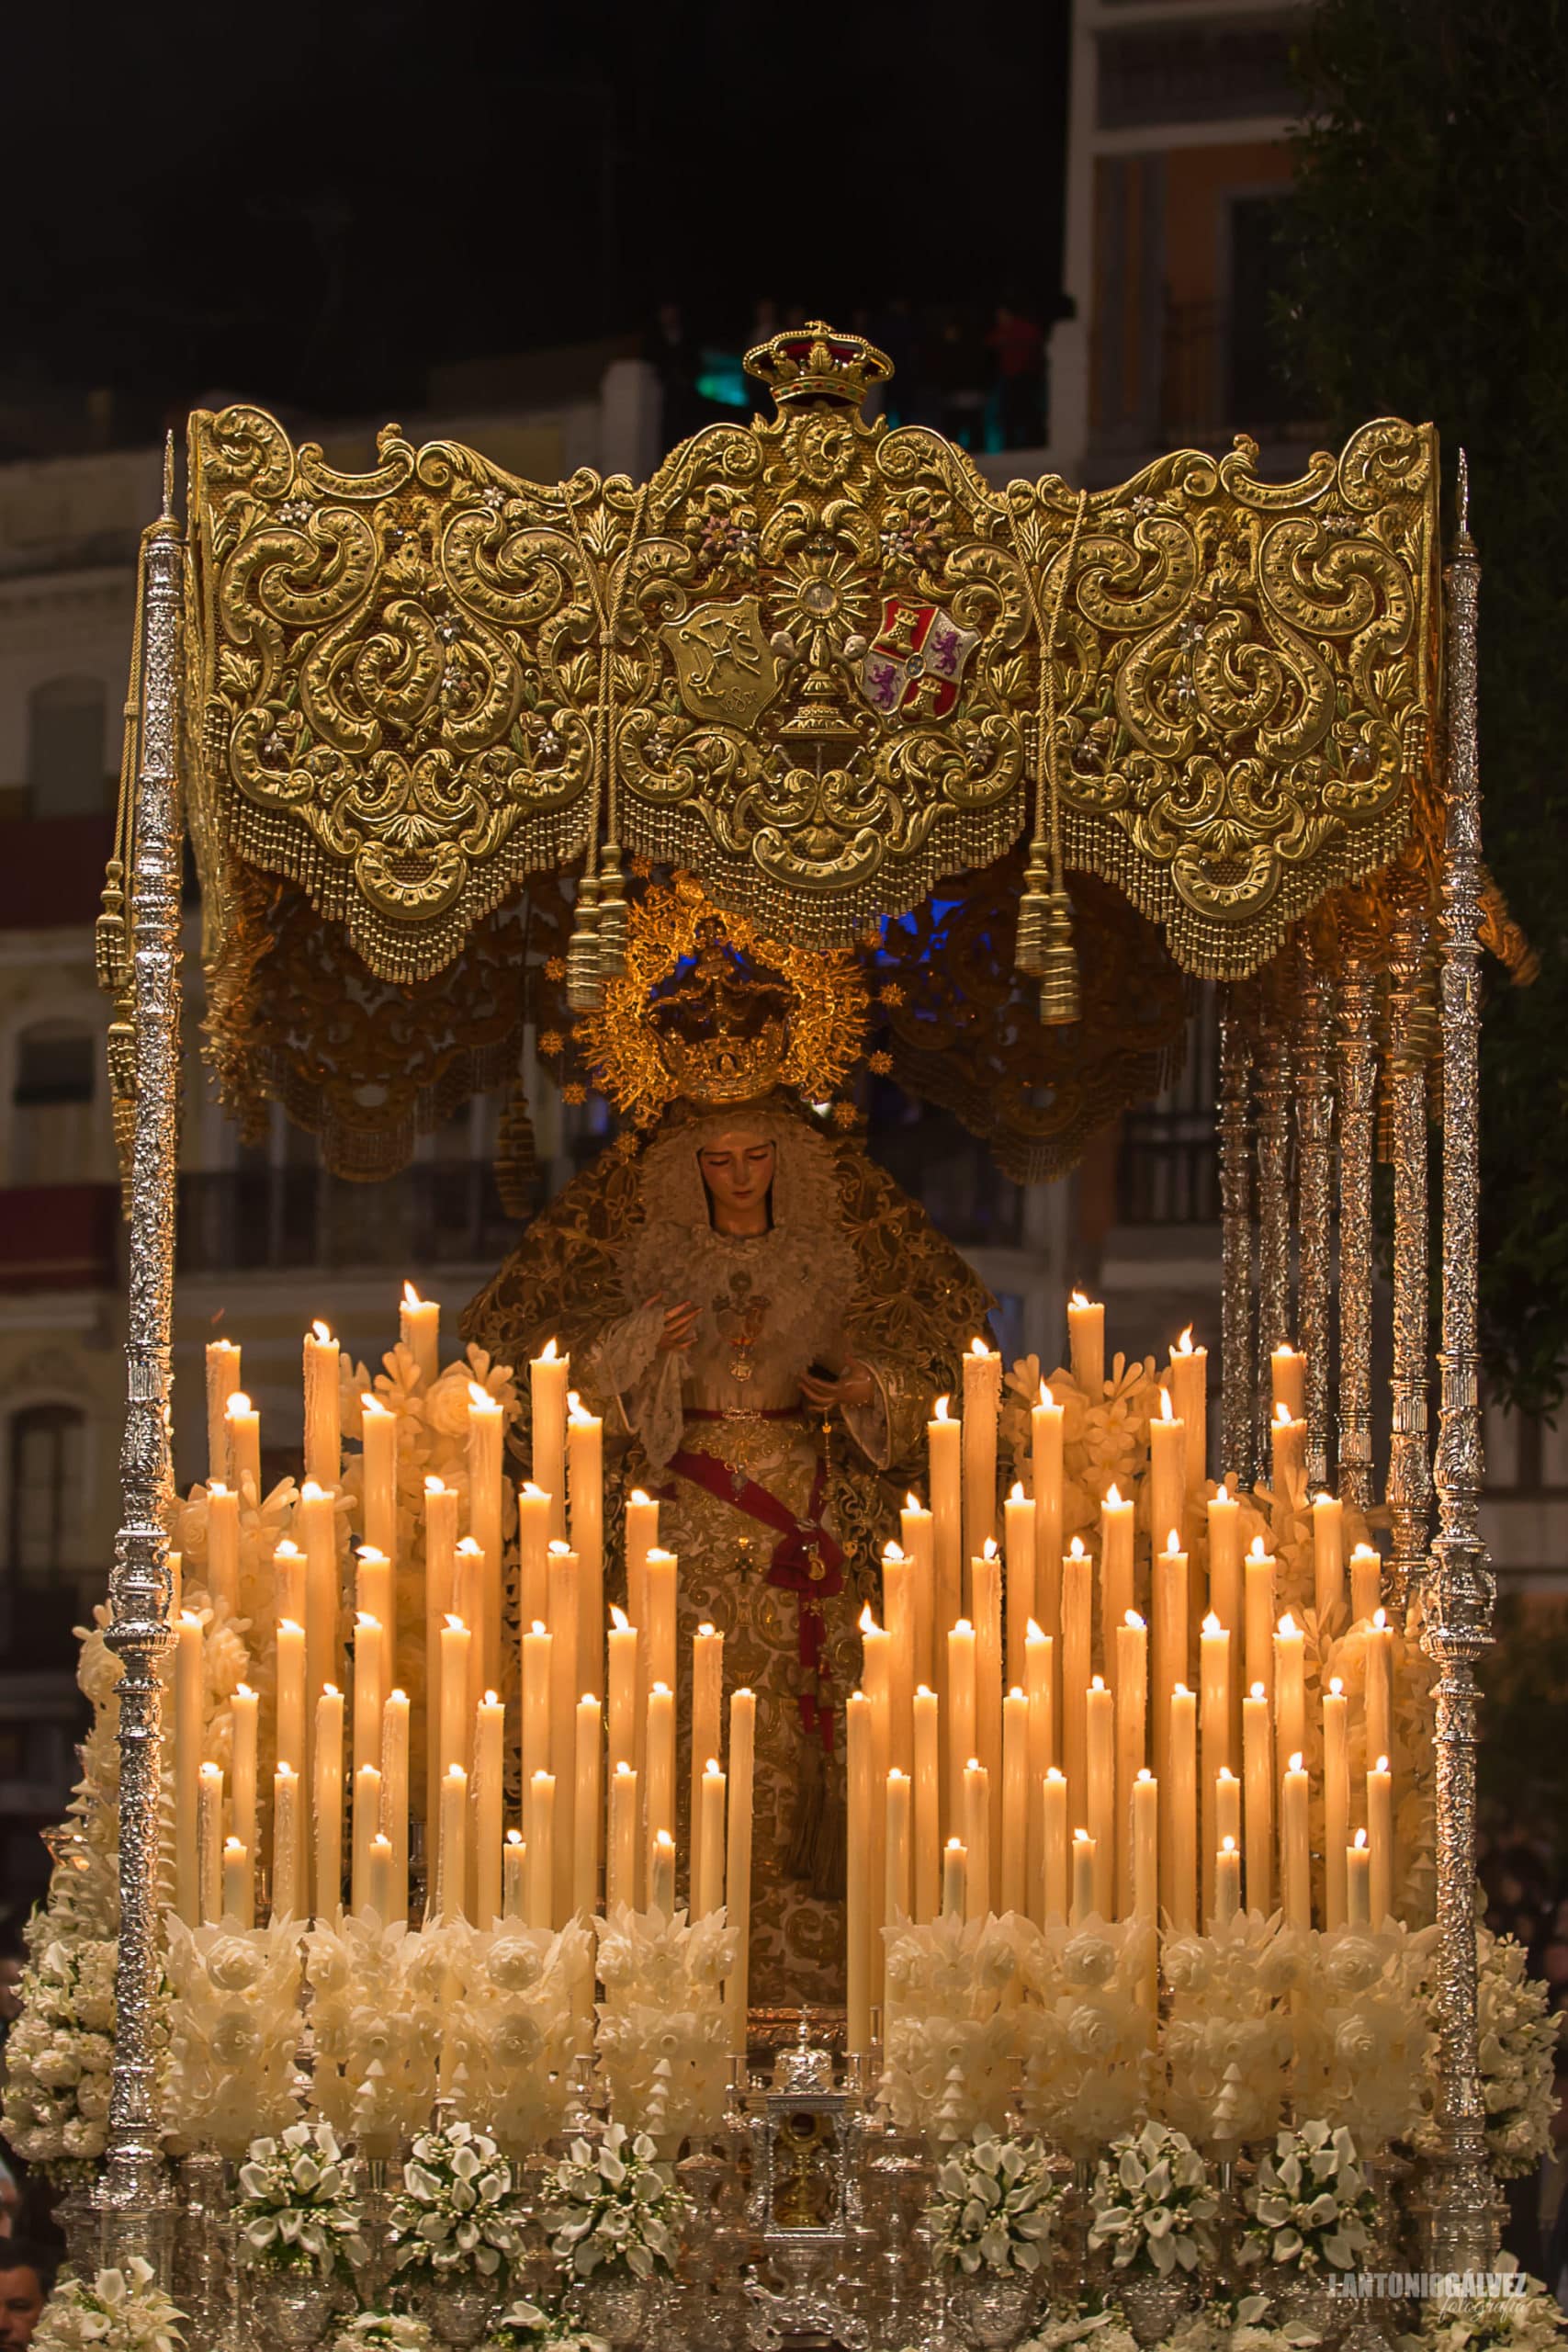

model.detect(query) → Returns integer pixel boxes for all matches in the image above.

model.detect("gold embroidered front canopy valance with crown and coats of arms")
[190,329,1434,981]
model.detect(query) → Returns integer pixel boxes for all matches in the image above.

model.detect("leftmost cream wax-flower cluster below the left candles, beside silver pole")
[164,1912,301,2157]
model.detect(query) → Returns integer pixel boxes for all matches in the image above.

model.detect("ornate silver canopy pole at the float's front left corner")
[98,461,186,2258]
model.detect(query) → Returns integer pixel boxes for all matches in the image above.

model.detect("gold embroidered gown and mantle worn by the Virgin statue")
[463,1096,992,2007]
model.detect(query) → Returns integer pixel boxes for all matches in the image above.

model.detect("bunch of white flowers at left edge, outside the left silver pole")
[0,1936,115,2180]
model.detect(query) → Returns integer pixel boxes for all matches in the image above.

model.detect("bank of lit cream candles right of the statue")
[846,1296,1394,2049]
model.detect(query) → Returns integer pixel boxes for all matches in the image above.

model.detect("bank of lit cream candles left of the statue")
[174,1286,757,2037]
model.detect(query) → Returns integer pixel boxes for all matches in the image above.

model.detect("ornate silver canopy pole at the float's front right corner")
[1422,457,1495,2269]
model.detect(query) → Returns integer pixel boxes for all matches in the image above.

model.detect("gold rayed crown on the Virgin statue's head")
[573,875,867,1126]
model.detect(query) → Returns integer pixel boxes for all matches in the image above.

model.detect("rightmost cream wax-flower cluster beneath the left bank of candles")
[597,1905,736,2138]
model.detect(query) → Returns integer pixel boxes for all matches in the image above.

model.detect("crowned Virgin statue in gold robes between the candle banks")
[466,879,992,2007]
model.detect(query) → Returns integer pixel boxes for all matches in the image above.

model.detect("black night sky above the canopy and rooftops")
[0,0,1067,425]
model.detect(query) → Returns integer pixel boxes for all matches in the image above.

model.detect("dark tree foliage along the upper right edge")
[1283,0,1568,1411]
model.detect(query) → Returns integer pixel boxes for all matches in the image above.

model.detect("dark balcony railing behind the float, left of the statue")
[179,1159,517,1275]
